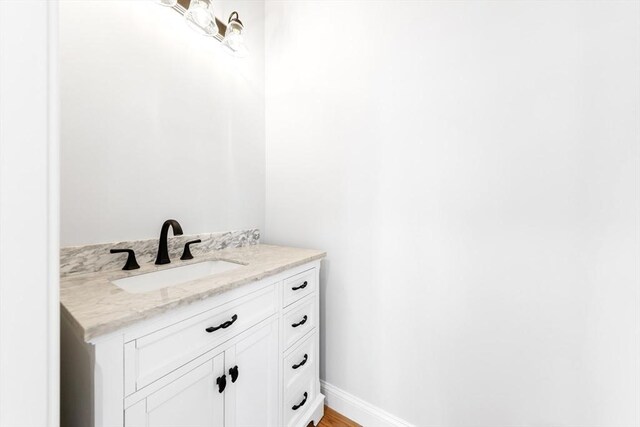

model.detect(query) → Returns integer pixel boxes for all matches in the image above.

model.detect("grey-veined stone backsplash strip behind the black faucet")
[60,229,260,276]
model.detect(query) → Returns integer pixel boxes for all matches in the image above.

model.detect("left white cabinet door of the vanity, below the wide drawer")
[125,354,228,427]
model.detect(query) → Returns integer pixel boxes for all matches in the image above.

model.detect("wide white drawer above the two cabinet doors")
[125,285,277,395]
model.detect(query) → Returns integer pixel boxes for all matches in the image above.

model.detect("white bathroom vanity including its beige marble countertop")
[61,239,324,427]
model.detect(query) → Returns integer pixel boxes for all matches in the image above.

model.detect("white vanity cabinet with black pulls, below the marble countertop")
[61,261,324,427]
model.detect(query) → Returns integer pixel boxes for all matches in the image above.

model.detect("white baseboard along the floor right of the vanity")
[320,380,414,427]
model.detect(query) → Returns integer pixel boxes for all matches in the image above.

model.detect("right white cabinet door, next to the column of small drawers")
[225,319,279,427]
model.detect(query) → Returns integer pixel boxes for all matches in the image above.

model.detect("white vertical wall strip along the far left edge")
[0,0,60,427]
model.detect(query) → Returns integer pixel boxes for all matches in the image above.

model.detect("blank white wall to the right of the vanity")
[264,1,640,427]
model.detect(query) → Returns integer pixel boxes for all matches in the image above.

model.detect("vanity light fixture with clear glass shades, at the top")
[159,0,248,58]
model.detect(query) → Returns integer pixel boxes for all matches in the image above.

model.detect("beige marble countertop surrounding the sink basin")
[60,244,325,342]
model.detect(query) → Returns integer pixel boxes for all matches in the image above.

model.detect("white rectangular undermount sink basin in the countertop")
[111,261,243,294]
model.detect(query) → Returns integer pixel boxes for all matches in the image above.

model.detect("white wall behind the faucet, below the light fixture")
[60,0,264,246]
